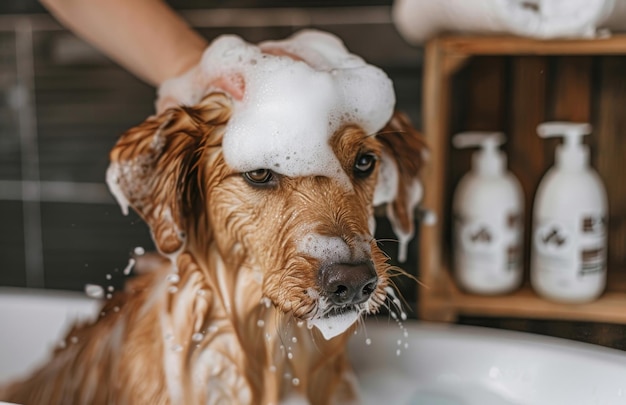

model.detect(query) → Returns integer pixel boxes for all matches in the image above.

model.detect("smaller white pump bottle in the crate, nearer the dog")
[452,132,524,295]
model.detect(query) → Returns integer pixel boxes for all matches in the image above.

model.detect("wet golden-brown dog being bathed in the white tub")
[0,40,426,405]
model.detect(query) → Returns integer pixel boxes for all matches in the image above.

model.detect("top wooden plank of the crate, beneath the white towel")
[434,35,626,55]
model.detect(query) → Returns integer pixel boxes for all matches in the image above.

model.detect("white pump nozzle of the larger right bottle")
[537,121,592,169]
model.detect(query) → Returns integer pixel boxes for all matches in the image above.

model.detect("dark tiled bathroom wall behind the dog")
[0,0,421,302]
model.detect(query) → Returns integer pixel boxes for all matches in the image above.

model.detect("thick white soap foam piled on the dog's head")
[201,31,395,183]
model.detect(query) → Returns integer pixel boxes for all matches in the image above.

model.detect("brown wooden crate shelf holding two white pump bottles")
[418,36,626,324]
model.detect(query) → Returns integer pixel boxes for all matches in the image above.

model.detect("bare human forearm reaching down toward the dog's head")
[41,0,207,86]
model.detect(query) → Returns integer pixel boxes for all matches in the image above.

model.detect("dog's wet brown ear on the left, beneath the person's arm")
[107,94,230,254]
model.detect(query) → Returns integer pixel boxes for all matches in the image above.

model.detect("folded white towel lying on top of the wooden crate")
[393,0,626,44]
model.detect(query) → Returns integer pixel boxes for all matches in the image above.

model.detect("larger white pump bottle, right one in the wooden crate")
[531,122,608,303]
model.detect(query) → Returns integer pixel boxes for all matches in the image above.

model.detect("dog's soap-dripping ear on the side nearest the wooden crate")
[374,112,428,262]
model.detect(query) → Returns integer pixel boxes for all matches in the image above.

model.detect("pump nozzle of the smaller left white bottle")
[452,131,506,175]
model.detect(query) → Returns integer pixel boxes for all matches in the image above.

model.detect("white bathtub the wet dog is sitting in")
[0,288,626,405]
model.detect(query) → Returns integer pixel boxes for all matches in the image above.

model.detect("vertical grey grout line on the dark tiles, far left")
[15,19,45,288]
